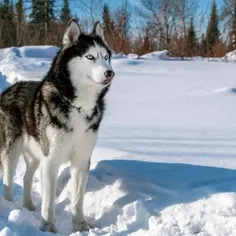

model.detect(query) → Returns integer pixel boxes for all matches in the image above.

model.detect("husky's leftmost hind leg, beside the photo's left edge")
[1,140,21,202]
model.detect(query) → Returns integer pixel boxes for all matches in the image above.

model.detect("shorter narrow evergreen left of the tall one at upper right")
[187,18,198,56]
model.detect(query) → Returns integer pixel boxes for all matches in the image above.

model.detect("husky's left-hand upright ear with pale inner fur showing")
[63,18,81,45]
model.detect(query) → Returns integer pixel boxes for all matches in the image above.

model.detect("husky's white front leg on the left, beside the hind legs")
[40,156,59,233]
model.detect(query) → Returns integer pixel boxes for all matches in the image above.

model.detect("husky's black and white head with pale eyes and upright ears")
[63,19,115,87]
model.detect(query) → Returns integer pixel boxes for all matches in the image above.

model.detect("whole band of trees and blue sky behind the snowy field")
[0,0,236,57]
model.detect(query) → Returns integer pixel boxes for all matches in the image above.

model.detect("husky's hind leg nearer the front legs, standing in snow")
[23,152,39,211]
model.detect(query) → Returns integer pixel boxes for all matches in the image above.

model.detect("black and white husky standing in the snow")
[0,19,115,233]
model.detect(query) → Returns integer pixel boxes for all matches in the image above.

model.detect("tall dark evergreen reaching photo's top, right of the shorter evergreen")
[206,1,220,54]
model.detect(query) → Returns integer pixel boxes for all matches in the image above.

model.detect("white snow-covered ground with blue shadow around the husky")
[0,47,236,236]
